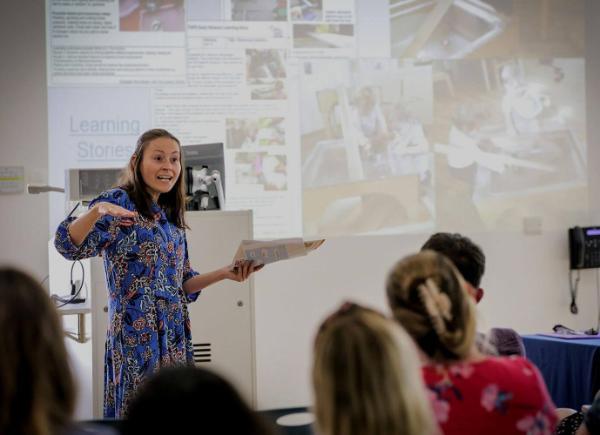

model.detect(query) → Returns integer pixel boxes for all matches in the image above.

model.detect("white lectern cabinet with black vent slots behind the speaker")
[91,211,256,418]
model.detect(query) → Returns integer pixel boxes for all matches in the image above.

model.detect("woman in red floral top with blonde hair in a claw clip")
[387,251,557,435]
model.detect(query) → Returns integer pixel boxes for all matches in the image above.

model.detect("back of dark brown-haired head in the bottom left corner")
[0,267,75,435]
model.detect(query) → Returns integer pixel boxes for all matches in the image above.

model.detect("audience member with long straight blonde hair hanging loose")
[312,303,439,435]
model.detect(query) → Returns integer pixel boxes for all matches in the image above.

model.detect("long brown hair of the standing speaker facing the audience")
[119,128,187,228]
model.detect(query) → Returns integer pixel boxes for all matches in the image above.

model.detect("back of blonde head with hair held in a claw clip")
[387,251,475,362]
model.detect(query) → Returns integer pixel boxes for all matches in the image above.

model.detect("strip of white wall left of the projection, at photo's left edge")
[0,0,48,281]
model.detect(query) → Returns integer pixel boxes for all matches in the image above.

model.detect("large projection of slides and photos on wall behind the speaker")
[46,0,591,238]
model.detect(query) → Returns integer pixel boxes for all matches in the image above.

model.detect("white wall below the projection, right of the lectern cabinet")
[255,230,598,409]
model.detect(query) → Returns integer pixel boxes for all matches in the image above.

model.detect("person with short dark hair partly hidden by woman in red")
[421,232,525,356]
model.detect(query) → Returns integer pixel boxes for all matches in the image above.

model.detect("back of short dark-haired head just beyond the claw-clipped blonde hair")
[421,233,485,288]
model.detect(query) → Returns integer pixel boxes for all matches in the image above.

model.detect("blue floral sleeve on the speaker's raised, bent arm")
[54,189,131,260]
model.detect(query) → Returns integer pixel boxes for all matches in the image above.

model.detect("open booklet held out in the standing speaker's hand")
[232,237,325,270]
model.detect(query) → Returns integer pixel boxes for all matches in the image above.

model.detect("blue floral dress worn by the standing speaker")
[55,188,198,418]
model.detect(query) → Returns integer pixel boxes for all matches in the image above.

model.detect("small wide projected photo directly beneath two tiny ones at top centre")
[293,23,354,48]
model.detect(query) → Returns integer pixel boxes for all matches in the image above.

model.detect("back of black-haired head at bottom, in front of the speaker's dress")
[122,366,271,435]
